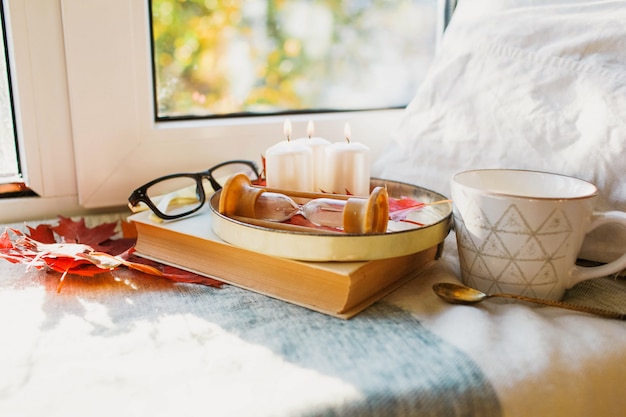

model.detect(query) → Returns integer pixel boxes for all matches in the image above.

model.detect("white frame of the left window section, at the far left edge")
[0,0,81,222]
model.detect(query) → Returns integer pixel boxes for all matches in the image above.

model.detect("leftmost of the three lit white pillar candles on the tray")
[265,120,313,192]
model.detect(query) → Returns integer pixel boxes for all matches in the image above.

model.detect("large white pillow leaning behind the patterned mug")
[372,0,626,261]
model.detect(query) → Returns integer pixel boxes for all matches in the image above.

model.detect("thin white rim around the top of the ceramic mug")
[452,168,598,201]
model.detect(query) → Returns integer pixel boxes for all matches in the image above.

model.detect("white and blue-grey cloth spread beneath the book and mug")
[0,218,626,417]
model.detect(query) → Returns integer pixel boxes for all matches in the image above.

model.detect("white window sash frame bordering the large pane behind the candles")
[62,0,410,207]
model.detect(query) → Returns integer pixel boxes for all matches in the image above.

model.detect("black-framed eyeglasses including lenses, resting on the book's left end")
[128,160,260,220]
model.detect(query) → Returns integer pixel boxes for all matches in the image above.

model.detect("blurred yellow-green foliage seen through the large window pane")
[150,0,437,120]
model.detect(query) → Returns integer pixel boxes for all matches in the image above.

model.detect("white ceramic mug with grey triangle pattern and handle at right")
[451,169,626,300]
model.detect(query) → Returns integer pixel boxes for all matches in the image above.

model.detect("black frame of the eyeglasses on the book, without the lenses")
[128,159,261,220]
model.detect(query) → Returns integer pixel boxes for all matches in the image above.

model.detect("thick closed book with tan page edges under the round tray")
[128,207,442,319]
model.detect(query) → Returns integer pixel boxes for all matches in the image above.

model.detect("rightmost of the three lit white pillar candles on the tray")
[322,123,371,196]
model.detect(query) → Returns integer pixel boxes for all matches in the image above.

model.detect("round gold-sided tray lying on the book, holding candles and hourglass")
[210,178,452,261]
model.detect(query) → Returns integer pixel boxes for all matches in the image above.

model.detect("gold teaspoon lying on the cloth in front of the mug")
[433,283,626,320]
